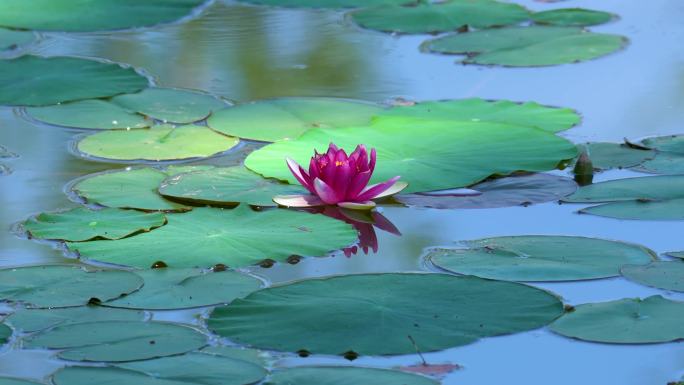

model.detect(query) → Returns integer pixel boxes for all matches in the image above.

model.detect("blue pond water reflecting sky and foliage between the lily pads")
[0,0,684,385]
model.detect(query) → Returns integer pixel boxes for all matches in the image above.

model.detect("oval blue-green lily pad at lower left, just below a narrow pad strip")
[24,321,207,362]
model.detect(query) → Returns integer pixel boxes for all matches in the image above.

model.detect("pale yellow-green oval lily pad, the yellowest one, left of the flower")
[76,125,239,161]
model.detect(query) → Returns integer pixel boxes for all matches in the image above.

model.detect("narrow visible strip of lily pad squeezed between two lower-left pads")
[7,305,145,333]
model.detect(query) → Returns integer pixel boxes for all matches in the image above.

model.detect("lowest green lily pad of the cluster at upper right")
[426,26,627,67]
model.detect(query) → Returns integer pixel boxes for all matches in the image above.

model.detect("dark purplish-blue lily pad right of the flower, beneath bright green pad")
[394,174,577,209]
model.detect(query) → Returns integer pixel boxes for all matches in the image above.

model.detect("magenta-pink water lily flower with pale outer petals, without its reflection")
[273,143,408,210]
